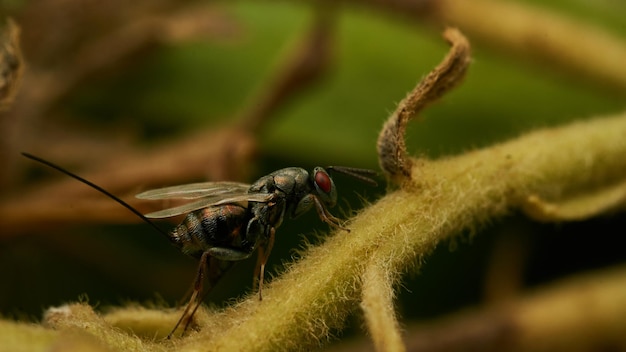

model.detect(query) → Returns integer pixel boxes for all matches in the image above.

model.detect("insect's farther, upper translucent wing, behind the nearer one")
[135,182,250,199]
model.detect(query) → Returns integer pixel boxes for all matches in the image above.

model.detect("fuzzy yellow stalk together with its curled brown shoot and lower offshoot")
[109,30,626,351]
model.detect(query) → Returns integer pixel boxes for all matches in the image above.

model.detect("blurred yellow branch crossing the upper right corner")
[326,0,626,94]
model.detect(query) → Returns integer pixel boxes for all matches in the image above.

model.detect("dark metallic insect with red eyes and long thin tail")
[22,153,376,338]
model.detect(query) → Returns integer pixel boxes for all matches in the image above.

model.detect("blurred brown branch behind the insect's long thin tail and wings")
[0,128,256,236]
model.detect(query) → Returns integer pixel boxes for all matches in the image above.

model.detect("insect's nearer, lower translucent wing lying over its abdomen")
[145,189,273,219]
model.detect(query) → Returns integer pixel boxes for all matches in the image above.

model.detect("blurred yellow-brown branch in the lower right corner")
[327,266,626,352]
